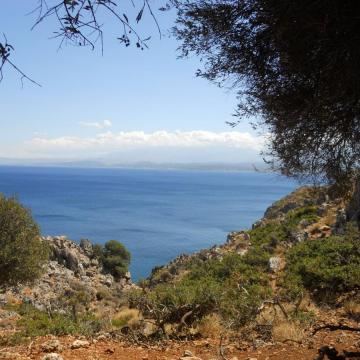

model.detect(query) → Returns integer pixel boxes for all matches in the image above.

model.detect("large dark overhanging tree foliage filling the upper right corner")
[173,0,360,188]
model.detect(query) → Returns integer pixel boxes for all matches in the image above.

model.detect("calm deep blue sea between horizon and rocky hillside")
[0,166,297,280]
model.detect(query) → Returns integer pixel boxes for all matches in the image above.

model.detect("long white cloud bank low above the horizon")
[30,130,266,151]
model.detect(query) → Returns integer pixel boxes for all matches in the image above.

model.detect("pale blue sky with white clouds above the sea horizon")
[0,0,265,162]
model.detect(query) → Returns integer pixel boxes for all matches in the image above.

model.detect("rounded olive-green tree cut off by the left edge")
[0,194,48,286]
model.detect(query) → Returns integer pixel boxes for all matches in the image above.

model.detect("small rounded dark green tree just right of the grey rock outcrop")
[102,240,131,279]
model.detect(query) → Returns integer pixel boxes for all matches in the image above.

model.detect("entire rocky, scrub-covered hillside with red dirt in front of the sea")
[0,187,360,360]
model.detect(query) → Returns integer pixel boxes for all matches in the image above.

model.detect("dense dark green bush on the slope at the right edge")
[284,225,360,301]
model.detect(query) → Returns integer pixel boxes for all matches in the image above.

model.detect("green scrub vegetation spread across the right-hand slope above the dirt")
[129,205,360,341]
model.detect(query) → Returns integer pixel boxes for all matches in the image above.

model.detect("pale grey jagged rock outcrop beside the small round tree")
[0,236,132,311]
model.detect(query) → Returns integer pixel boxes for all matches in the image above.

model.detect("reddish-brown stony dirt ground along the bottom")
[0,330,360,360]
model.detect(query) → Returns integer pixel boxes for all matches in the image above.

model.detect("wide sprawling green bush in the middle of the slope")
[130,254,271,328]
